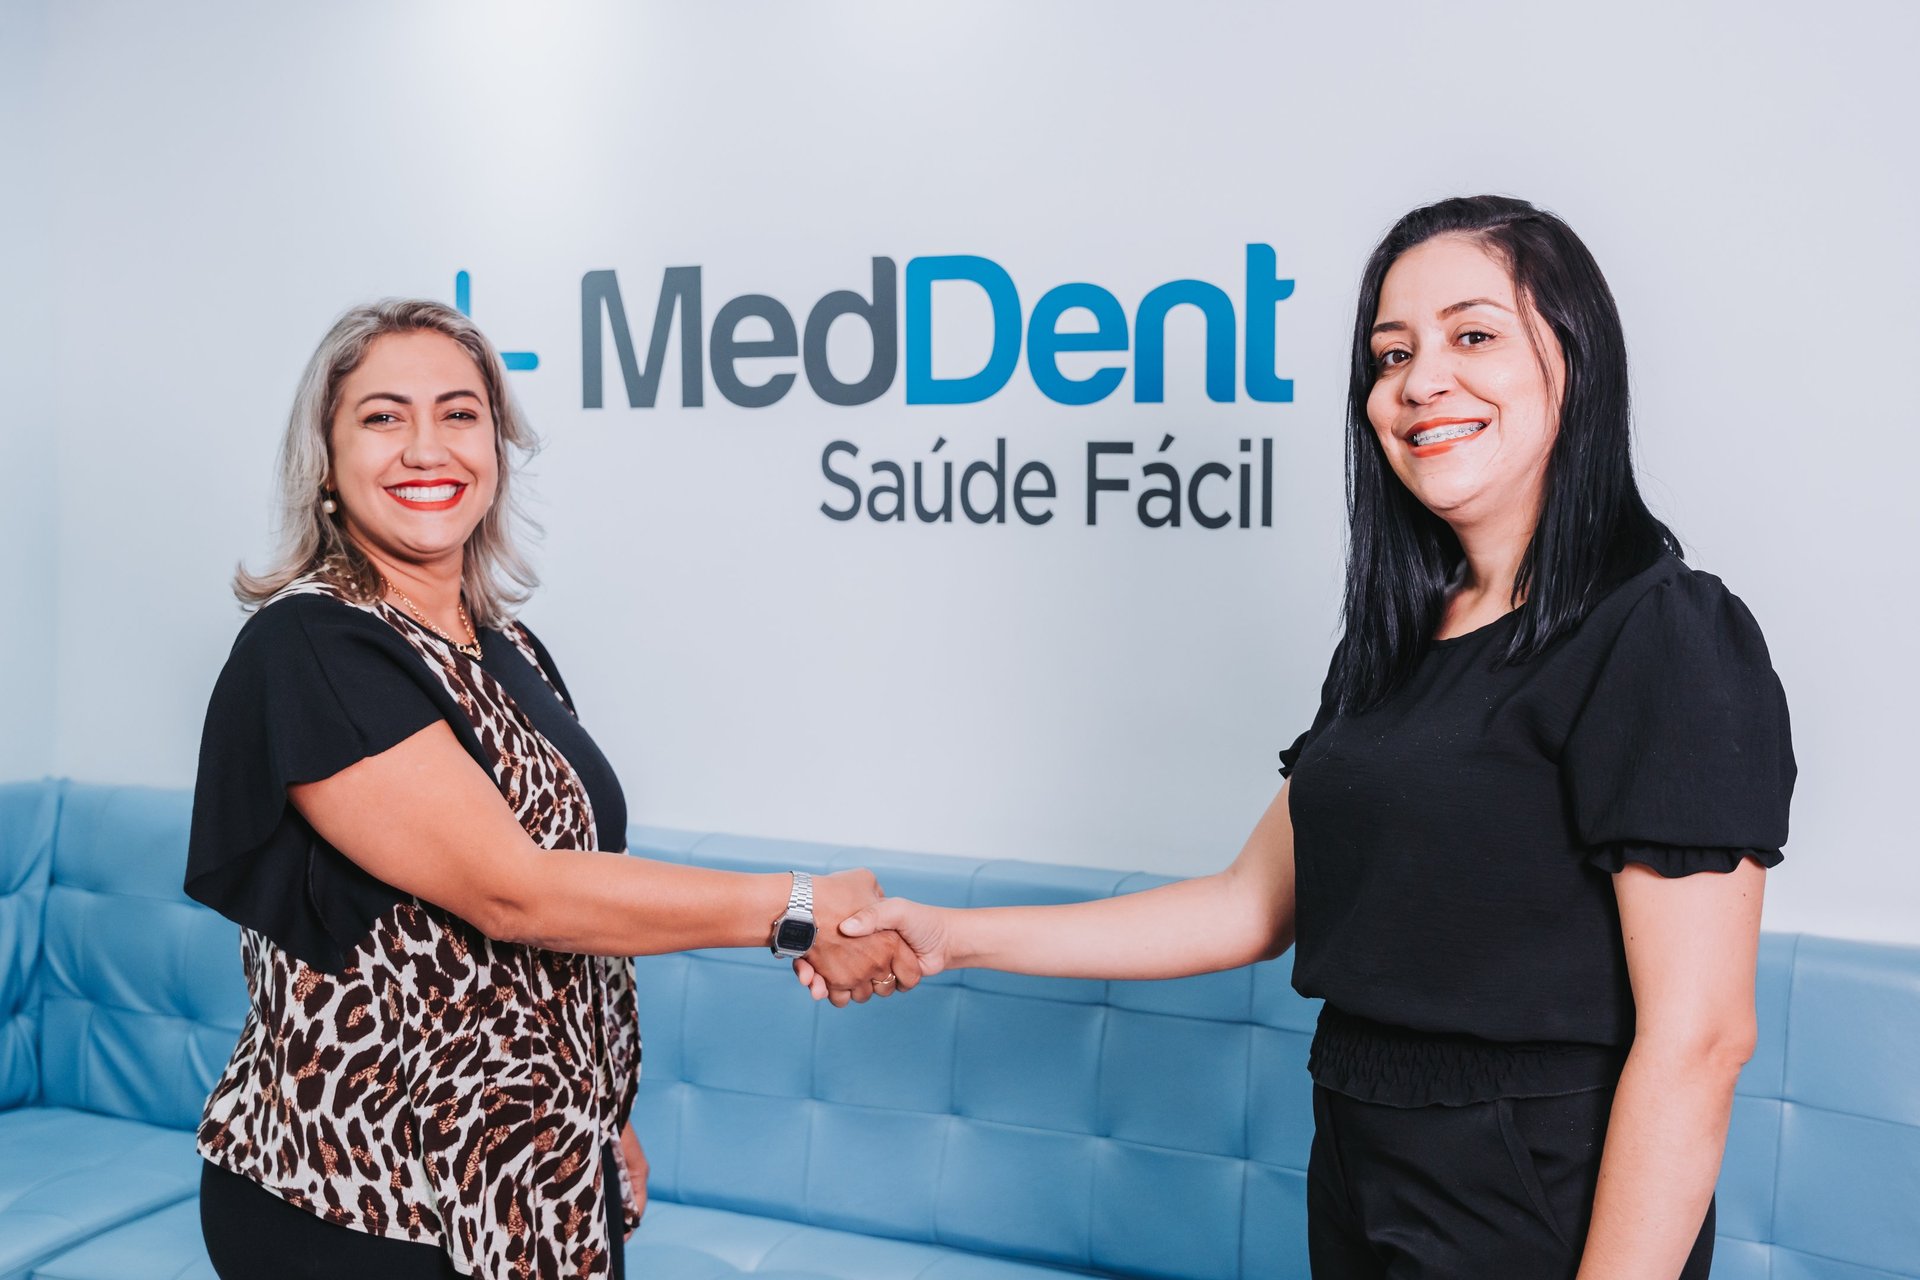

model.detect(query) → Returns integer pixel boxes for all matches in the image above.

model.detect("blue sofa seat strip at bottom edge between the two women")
[626,1199,1085,1280]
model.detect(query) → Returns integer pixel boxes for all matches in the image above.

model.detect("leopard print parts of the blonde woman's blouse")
[198,574,641,1280]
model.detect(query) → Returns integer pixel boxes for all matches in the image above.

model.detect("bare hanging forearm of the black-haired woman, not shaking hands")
[1578,1044,1740,1280]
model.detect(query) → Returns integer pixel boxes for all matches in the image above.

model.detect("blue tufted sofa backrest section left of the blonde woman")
[36,783,246,1128]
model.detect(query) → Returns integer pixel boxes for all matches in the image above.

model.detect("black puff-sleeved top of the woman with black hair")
[1281,555,1795,1105]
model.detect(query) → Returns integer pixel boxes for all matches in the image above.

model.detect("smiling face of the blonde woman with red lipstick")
[328,330,499,572]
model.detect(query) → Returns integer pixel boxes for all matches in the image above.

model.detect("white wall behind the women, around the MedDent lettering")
[0,0,1920,940]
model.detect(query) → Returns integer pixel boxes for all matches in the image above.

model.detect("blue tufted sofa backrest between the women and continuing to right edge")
[632,827,1920,1280]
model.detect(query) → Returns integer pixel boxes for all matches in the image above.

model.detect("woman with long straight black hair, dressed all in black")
[797,196,1795,1280]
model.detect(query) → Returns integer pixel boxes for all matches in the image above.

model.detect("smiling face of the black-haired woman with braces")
[1367,234,1567,528]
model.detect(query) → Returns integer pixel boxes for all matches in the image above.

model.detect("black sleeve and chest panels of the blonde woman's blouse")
[186,595,626,971]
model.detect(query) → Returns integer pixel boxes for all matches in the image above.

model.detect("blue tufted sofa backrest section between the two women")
[632,829,1317,1280]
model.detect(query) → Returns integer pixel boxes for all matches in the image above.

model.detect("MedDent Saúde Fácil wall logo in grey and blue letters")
[466,244,1294,530]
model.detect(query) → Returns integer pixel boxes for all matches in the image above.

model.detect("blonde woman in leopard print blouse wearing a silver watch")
[186,299,918,1280]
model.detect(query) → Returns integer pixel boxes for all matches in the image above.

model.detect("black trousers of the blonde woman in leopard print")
[200,1146,626,1280]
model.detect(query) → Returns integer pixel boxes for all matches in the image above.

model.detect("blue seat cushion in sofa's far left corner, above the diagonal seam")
[0,1107,200,1280]
